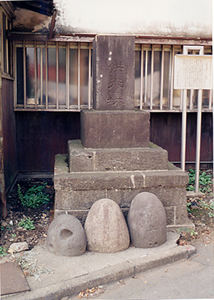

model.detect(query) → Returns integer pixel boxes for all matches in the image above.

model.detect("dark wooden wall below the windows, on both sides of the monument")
[16,112,212,173]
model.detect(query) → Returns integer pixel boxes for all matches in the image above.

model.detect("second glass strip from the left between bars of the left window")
[26,48,35,104]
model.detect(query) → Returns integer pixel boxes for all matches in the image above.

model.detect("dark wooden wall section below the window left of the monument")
[16,112,80,173]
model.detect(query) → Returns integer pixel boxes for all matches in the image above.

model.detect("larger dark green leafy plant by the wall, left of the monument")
[17,183,50,208]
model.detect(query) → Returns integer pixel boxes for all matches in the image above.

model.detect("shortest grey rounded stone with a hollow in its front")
[46,214,86,256]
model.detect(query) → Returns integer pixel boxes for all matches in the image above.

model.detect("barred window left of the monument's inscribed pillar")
[15,42,92,110]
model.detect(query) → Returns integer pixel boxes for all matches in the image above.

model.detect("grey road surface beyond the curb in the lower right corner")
[69,238,214,300]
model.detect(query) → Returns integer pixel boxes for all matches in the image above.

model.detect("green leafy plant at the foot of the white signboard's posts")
[187,169,212,193]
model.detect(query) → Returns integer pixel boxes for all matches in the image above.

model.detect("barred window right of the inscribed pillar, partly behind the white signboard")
[135,45,212,111]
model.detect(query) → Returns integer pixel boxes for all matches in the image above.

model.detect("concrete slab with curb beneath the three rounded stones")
[1,232,195,300]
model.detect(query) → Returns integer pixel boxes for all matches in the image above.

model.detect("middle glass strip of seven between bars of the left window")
[48,48,56,105]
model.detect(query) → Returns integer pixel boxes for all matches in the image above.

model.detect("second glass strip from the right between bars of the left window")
[69,49,78,105]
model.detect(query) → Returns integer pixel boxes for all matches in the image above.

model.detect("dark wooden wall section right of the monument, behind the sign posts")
[150,113,213,165]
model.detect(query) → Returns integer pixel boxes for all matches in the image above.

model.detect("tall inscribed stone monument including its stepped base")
[54,35,191,228]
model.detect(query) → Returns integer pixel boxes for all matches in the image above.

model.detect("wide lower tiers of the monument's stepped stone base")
[54,141,192,228]
